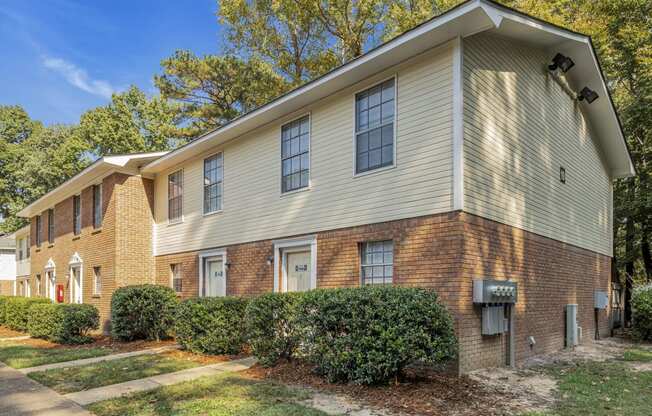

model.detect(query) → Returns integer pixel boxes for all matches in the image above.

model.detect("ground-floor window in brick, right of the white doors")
[360,240,394,285]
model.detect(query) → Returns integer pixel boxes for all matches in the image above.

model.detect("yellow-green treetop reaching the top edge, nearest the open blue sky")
[218,0,340,85]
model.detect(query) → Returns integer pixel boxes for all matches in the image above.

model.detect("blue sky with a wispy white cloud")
[0,0,222,124]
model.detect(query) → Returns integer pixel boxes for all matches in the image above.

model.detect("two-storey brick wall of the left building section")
[31,173,153,332]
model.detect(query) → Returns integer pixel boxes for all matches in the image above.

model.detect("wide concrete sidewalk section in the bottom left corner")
[0,363,92,416]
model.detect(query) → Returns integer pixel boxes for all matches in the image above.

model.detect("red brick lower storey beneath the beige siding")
[156,212,611,372]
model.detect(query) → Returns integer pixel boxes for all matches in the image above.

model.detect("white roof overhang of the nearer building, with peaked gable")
[142,0,635,177]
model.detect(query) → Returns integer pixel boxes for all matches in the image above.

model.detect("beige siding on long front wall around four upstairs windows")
[155,43,452,255]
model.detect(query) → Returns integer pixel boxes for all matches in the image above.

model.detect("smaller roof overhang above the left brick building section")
[18,152,168,218]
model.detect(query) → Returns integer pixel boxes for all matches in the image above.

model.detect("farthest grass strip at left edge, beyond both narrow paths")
[0,344,113,368]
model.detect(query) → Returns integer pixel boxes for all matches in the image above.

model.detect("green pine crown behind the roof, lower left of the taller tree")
[155,51,290,137]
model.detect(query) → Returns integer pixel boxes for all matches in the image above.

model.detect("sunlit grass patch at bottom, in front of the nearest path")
[88,373,326,416]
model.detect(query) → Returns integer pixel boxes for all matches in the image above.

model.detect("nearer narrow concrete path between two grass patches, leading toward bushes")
[65,357,256,404]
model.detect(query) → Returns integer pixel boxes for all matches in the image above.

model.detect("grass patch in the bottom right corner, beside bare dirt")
[529,362,652,416]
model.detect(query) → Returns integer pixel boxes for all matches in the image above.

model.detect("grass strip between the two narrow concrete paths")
[29,355,200,394]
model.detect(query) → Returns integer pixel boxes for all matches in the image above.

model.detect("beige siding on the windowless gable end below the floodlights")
[463,35,612,256]
